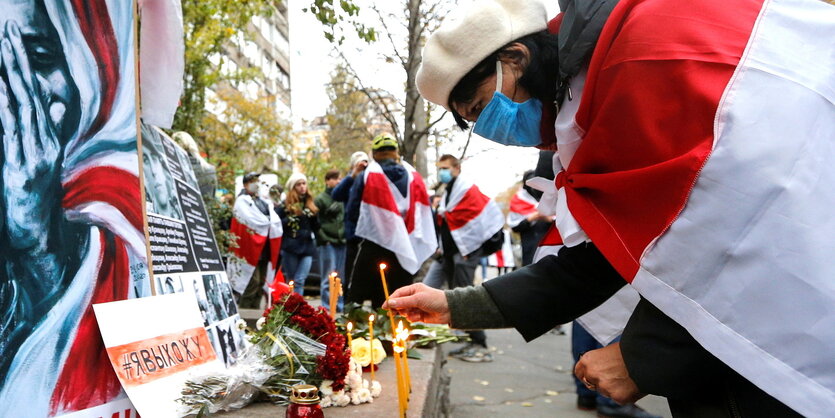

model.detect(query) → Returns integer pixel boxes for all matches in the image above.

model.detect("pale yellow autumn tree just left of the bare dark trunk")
[326,65,370,165]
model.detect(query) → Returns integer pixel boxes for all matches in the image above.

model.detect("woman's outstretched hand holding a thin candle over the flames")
[383,283,450,324]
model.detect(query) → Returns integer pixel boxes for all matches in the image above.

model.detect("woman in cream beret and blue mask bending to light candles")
[388,0,835,416]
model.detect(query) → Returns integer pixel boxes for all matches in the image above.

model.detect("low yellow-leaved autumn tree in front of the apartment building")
[195,88,291,190]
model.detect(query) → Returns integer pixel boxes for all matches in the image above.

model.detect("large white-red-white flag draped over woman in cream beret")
[560,0,835,416]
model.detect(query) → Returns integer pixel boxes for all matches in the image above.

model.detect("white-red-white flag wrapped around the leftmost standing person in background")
[226,194,284,293]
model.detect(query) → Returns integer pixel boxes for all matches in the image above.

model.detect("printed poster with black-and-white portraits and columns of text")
[142,123,245,365]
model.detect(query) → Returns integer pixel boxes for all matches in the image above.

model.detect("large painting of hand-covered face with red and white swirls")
[0,0,143,416]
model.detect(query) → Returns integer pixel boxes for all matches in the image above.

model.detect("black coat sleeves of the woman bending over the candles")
[446,243,797,417]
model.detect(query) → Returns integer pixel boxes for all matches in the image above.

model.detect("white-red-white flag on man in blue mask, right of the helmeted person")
[438,176,504,255]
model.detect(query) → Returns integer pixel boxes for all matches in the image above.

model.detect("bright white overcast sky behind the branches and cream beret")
[289,0,558,196]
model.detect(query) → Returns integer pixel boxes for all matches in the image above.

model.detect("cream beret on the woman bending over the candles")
[417,0,548,110]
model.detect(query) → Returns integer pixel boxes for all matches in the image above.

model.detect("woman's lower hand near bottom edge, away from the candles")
[574,343,645,405]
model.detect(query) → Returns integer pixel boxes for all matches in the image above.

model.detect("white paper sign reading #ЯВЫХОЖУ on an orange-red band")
[93,293,224,417]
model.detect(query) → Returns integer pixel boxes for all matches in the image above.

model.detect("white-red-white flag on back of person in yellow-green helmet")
[356,161,438,274]
